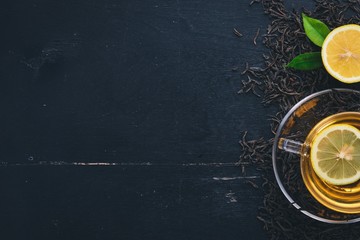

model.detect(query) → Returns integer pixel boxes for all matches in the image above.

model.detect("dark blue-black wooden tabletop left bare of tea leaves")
[0,0,314,240]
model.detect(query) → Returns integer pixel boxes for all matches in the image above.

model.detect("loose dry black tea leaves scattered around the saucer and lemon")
[239,0,360,240]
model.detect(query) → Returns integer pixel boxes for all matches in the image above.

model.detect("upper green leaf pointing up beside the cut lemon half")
[302,13,330,47]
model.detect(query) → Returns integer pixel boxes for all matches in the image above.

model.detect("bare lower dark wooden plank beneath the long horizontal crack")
[0,166,262,239]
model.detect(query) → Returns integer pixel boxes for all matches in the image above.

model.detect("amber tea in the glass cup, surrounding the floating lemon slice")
[300,112,360,214]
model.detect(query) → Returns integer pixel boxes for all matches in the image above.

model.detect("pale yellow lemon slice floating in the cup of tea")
[310,124,360,185]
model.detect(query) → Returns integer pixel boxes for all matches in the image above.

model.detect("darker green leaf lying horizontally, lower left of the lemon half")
[286,52,323,70]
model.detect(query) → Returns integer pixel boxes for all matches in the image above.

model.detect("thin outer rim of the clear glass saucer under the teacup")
[272,88,360,224]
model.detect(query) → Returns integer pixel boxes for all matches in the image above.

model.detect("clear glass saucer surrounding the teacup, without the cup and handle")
[272,88,360,224]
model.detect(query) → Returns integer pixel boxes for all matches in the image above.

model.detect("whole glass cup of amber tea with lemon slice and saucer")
[272,89,360,223]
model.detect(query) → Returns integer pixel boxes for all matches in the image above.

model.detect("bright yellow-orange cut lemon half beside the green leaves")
[321,24,360,83]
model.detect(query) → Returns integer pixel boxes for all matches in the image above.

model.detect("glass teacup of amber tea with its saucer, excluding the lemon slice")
[272,89,360,223]
